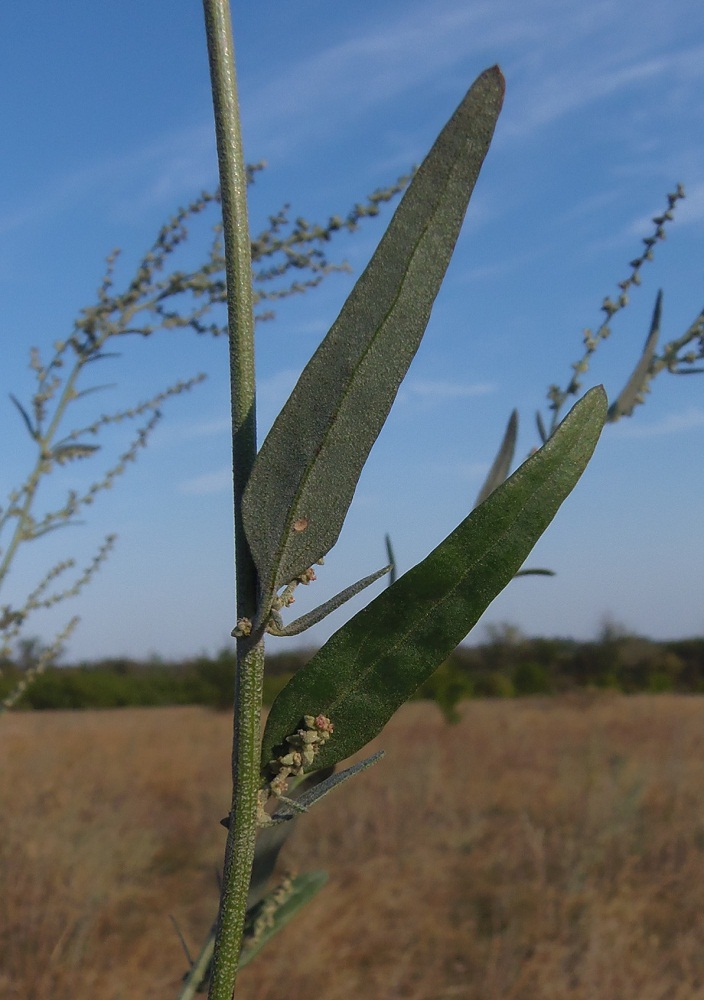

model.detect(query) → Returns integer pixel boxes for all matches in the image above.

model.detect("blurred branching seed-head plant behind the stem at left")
[0,164,407,711]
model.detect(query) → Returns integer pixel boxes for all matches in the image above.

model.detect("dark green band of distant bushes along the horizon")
[5,624,704,720]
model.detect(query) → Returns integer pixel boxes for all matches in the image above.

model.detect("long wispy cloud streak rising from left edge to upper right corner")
[6,0,704,242]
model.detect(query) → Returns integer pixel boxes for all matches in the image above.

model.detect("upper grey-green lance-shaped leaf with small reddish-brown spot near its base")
[242,67,504,613]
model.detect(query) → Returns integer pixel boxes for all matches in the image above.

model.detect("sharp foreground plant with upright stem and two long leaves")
[187,0,607,1000]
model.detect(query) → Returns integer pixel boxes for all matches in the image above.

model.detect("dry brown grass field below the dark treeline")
[0,695,704,1000]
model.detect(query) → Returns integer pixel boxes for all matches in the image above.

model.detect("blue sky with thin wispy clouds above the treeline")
[0,0,704,658]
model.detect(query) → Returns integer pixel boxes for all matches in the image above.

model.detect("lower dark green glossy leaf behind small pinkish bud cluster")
[262,387,607,768]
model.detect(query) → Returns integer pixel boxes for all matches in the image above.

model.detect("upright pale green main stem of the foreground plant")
[203,0,264,1000]
